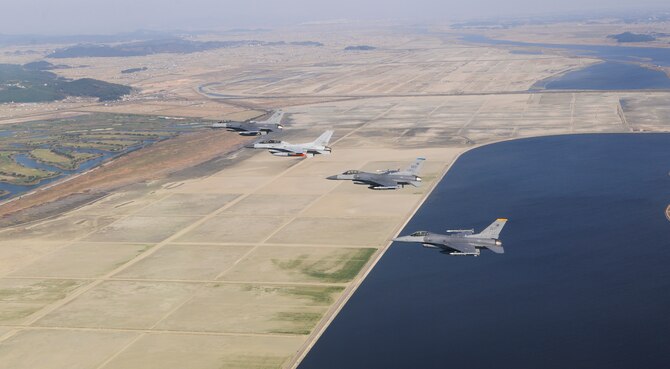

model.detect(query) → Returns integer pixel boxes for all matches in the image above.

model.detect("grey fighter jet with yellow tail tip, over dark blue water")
[393,218,507,256]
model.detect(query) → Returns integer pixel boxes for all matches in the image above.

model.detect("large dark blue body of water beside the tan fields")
[300,134,670,369]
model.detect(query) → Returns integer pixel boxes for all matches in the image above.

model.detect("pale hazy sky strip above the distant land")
[5,0,670,34]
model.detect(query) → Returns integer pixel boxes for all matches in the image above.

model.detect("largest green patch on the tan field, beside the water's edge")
[272,248,376,283]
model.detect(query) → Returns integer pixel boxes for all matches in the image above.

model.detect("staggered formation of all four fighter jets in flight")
[217,110,507,256]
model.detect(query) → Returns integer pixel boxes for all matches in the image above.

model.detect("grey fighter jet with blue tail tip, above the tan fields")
[327,158,426,190]
